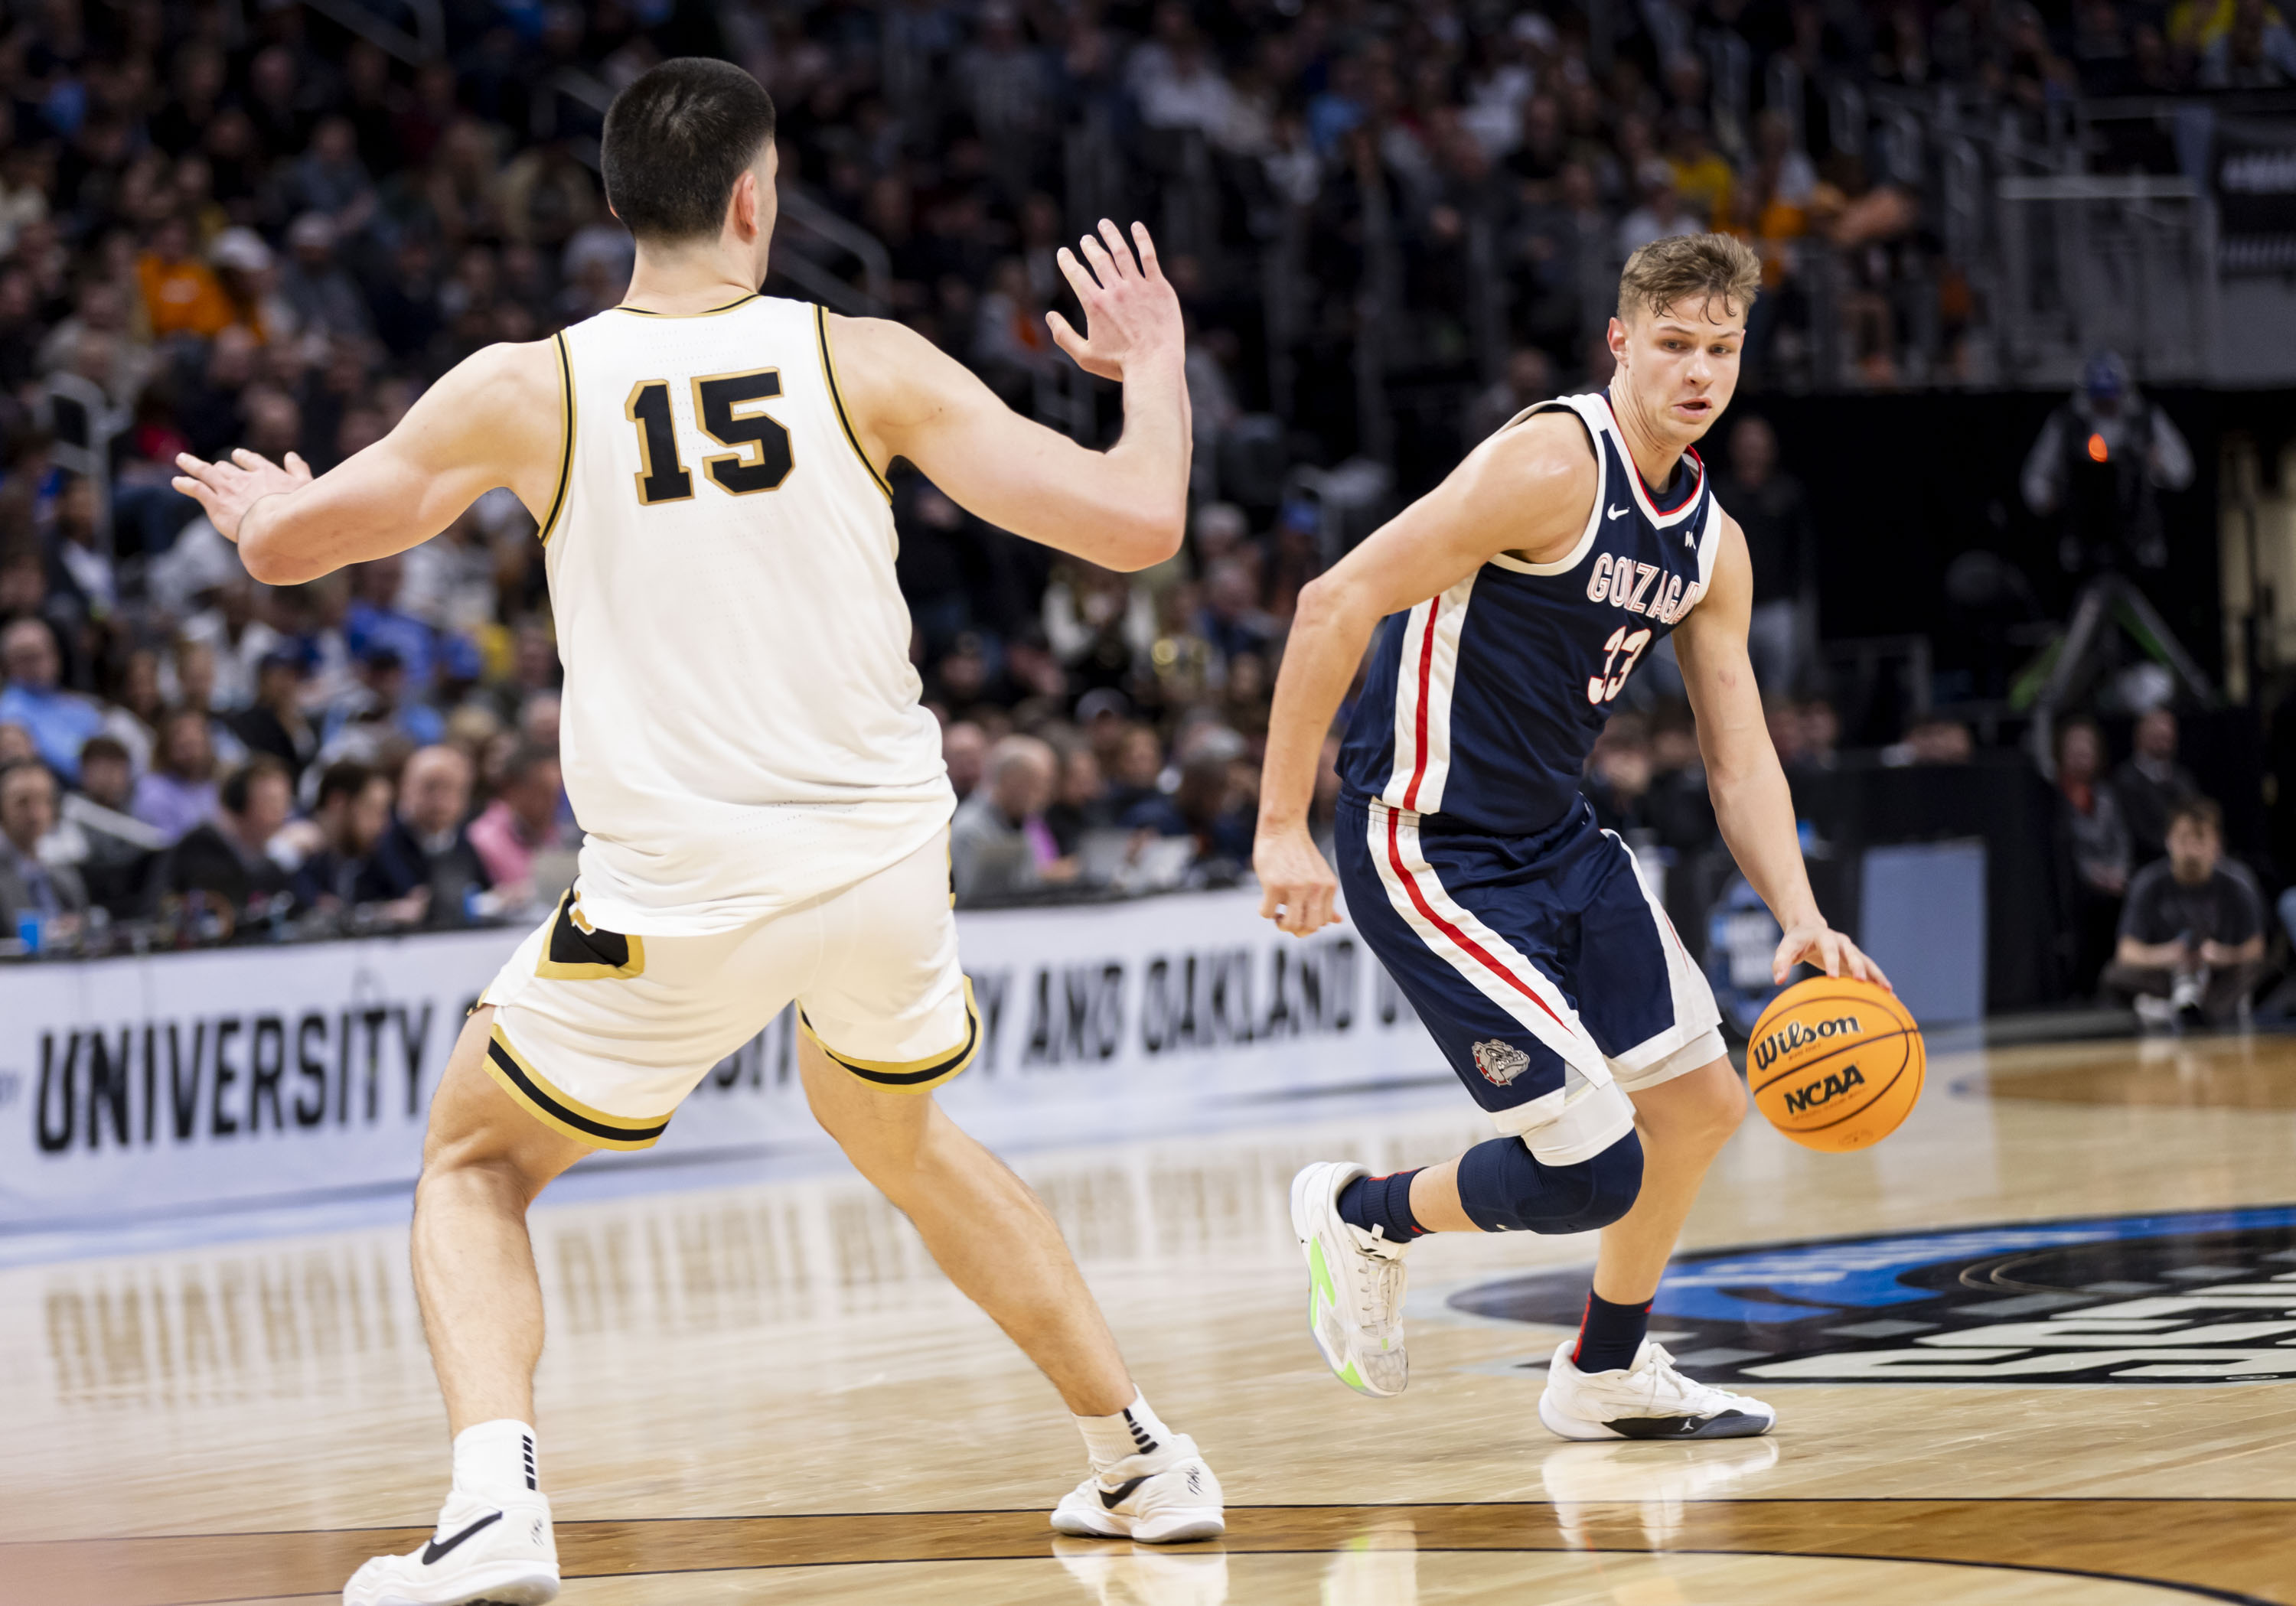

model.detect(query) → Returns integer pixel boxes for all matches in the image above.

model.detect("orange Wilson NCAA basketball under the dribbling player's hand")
[1745,975,1929,1154]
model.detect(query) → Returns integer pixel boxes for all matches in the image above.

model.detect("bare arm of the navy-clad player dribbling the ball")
[1674,514,1890,986]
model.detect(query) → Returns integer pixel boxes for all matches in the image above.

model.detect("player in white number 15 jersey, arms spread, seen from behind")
[177,57,1224,1606]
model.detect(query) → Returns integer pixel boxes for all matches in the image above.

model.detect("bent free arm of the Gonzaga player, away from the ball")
[1251,413,1596,936]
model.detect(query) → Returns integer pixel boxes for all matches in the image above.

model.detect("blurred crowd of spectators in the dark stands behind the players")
[0,0,2296,1028]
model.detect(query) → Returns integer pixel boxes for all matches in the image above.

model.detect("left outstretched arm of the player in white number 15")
[174,340,565,585]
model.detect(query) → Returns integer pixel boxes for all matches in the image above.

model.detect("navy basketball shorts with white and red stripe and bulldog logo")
[1339,796,1724,1163]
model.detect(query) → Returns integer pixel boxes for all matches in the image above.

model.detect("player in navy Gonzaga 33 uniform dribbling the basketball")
[1254,234,1885,1438]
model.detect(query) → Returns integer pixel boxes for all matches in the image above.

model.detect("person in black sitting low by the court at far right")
[2103,799,2264,1025]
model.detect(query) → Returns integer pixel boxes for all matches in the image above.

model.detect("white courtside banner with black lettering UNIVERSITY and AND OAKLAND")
[0,892,1442,1227]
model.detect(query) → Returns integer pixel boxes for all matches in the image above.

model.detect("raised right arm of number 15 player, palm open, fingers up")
[829,220,1192,572]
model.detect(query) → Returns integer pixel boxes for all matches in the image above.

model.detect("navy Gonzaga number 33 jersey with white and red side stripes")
[1339,393,1722,837]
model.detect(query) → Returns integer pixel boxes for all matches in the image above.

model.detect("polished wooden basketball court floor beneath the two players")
[0,1037,2296,1606]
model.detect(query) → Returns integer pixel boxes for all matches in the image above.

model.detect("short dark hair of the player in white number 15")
[599,55,774,241]
